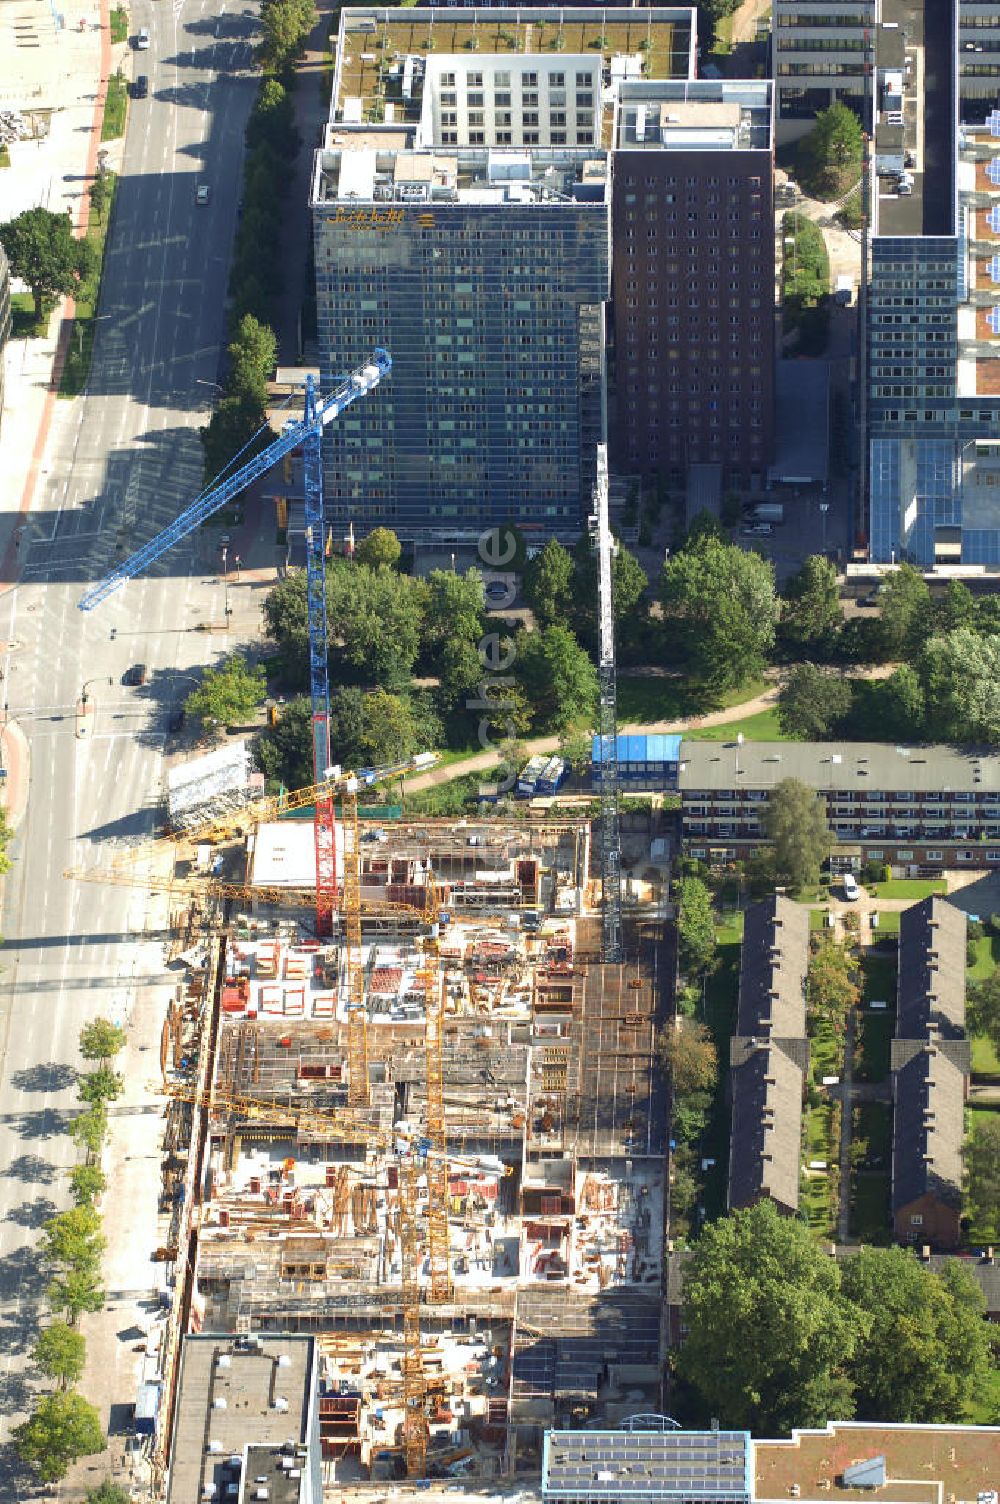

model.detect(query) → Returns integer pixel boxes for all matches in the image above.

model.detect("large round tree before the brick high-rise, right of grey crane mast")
[660,537,777,698]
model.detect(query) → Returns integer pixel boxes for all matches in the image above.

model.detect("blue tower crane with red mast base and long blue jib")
[78,349,392,934]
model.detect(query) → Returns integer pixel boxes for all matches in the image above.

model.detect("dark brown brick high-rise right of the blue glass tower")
[611,80,774,489]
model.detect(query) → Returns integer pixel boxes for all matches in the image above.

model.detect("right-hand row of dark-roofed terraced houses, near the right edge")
[890,898,970,1248]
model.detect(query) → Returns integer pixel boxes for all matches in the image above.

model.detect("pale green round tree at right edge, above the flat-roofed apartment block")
[919,627,1000,741]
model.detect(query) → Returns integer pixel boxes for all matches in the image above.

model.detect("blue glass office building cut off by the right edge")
[866,0,1000,567]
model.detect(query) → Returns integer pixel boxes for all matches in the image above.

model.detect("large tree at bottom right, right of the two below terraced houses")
[842,1248,989,1424]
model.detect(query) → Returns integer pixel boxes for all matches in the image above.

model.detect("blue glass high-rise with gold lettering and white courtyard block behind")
[310,8,695,540]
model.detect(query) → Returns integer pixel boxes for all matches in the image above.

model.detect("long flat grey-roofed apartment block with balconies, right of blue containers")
[678,741,1000,877]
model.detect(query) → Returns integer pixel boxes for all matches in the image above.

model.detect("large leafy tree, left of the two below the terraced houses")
[678,1200,862,1436]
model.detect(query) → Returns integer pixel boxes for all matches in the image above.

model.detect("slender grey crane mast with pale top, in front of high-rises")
[591,444,621,964]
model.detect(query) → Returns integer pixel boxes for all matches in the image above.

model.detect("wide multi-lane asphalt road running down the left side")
[0,0,256,1479]
